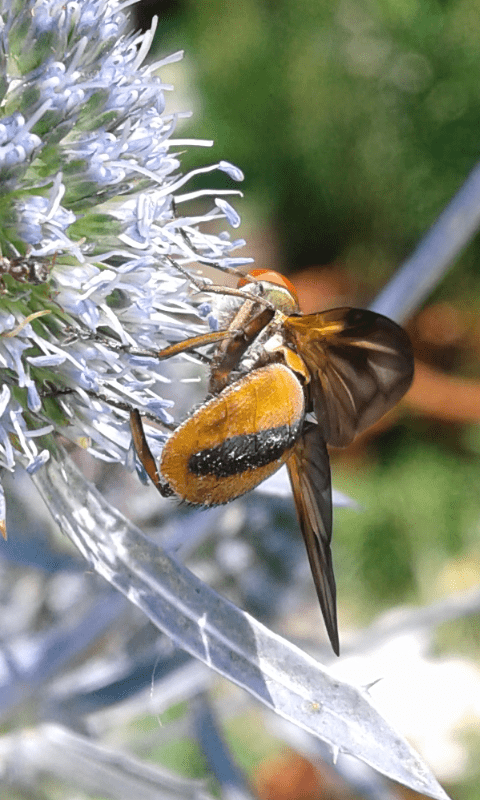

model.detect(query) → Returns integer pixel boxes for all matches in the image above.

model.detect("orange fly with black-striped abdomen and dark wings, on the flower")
[131,270,413,654]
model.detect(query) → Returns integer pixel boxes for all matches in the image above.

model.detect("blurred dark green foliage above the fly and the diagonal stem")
[155,0,480,286]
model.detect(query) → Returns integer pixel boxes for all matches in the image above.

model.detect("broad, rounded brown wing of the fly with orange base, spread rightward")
[285,308,413,447]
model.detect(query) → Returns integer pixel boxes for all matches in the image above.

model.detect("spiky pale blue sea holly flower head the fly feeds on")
[0,0,249,532]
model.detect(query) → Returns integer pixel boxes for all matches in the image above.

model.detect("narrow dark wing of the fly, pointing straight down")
[287,424,340,656]
